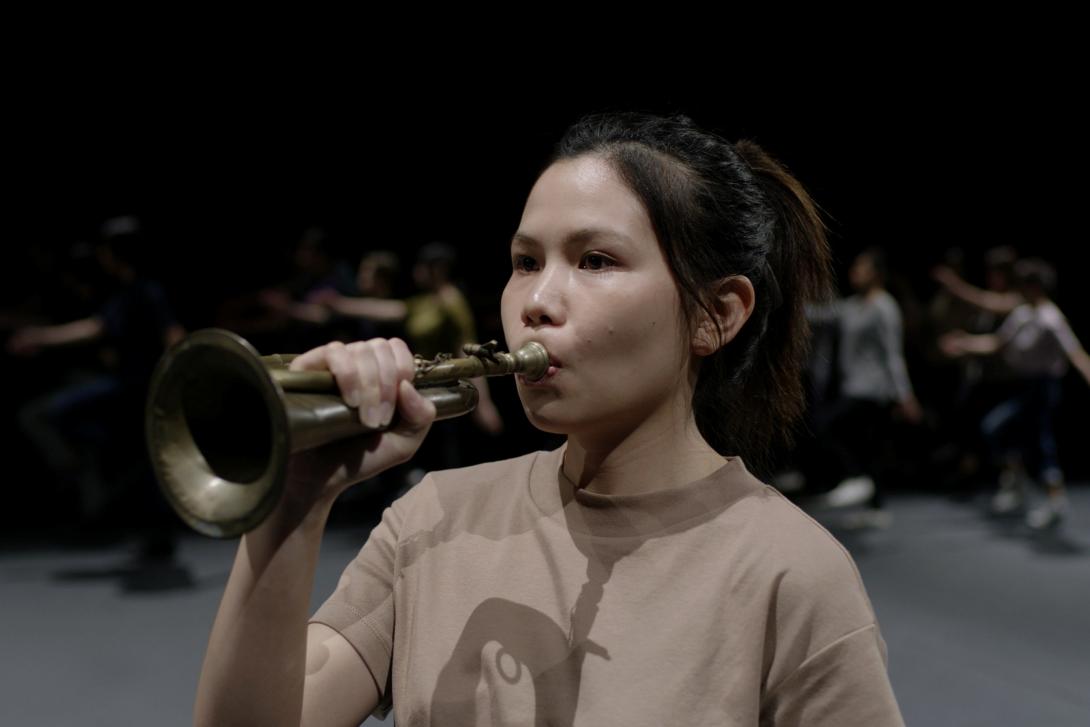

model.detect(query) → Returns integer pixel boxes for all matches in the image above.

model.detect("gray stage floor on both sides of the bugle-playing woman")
[0,485,1090,727]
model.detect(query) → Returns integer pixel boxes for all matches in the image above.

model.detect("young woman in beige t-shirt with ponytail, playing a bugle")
[196,114,901,727]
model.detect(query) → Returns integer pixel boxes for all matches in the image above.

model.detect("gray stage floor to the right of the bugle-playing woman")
[820,486,1090,727]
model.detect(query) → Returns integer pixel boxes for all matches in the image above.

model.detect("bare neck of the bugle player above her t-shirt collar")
[564,413,724,495]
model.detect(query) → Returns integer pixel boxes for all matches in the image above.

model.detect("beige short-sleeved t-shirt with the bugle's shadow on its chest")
[313,447,903,727]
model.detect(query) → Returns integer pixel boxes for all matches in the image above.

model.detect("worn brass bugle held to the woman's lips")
[145,328,548,537]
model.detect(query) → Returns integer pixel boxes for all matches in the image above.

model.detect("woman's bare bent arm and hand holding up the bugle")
[194,339,435,727]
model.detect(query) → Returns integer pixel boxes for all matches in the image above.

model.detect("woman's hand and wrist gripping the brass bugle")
[288,338,435,509]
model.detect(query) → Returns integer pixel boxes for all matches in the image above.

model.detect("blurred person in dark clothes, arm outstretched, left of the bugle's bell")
[7,217,185,559]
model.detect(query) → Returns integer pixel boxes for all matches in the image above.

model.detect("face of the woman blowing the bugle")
[501,156,692,435]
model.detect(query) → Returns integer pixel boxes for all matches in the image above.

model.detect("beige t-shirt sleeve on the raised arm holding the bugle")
[311,494,402,705]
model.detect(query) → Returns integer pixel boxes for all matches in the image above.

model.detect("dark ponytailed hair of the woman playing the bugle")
[548,107,832,472]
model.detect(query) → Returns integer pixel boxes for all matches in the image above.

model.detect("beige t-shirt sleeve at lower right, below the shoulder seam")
[761,623,905,727]
